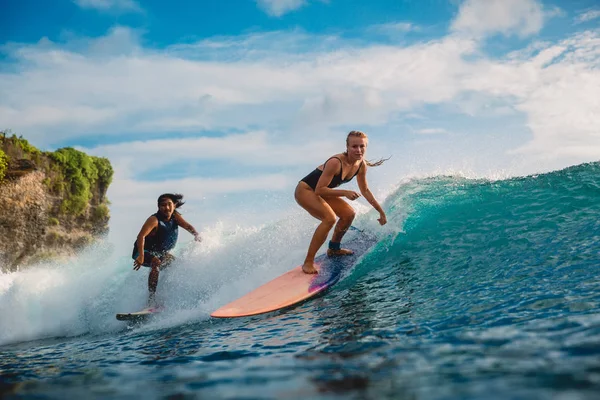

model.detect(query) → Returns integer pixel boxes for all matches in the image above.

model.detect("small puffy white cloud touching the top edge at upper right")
[452,0,544,37]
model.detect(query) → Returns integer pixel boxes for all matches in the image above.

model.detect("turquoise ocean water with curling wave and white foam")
[0,163,600,399]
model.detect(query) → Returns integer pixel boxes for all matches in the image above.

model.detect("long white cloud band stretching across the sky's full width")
[0,16,600,180]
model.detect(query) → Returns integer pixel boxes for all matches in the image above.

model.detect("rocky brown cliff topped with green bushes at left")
[0,132,113,271]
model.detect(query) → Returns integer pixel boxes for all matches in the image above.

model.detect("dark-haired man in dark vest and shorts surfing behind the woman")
[132,193,202,306]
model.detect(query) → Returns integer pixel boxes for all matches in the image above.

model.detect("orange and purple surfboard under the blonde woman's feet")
[211,237,375,318]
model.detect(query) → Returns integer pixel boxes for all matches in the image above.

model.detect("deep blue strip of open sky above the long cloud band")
[2,0,457,48]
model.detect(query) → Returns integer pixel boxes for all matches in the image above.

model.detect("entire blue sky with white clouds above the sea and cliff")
[0,0,600,238]
